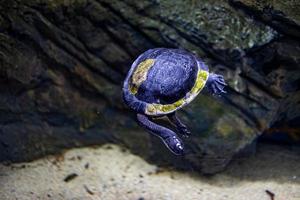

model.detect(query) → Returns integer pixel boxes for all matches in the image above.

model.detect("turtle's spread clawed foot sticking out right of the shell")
[206,73,227,95]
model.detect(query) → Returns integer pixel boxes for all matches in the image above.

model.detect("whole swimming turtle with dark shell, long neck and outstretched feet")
[122,48,226,155]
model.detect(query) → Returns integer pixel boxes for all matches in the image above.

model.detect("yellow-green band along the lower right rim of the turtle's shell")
[146,69,209,115]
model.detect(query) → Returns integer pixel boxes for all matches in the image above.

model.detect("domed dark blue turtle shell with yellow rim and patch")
[123,48,209,116]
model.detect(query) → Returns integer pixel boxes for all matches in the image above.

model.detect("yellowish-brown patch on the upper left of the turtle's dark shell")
[130,59,155,94]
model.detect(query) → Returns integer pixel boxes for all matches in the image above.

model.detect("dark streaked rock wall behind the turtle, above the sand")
[0,0,300,174]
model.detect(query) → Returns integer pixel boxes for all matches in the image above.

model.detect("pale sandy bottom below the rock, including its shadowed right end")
[0,145,300,200]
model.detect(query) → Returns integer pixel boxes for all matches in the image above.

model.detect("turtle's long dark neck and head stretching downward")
[137,114,184,155]
